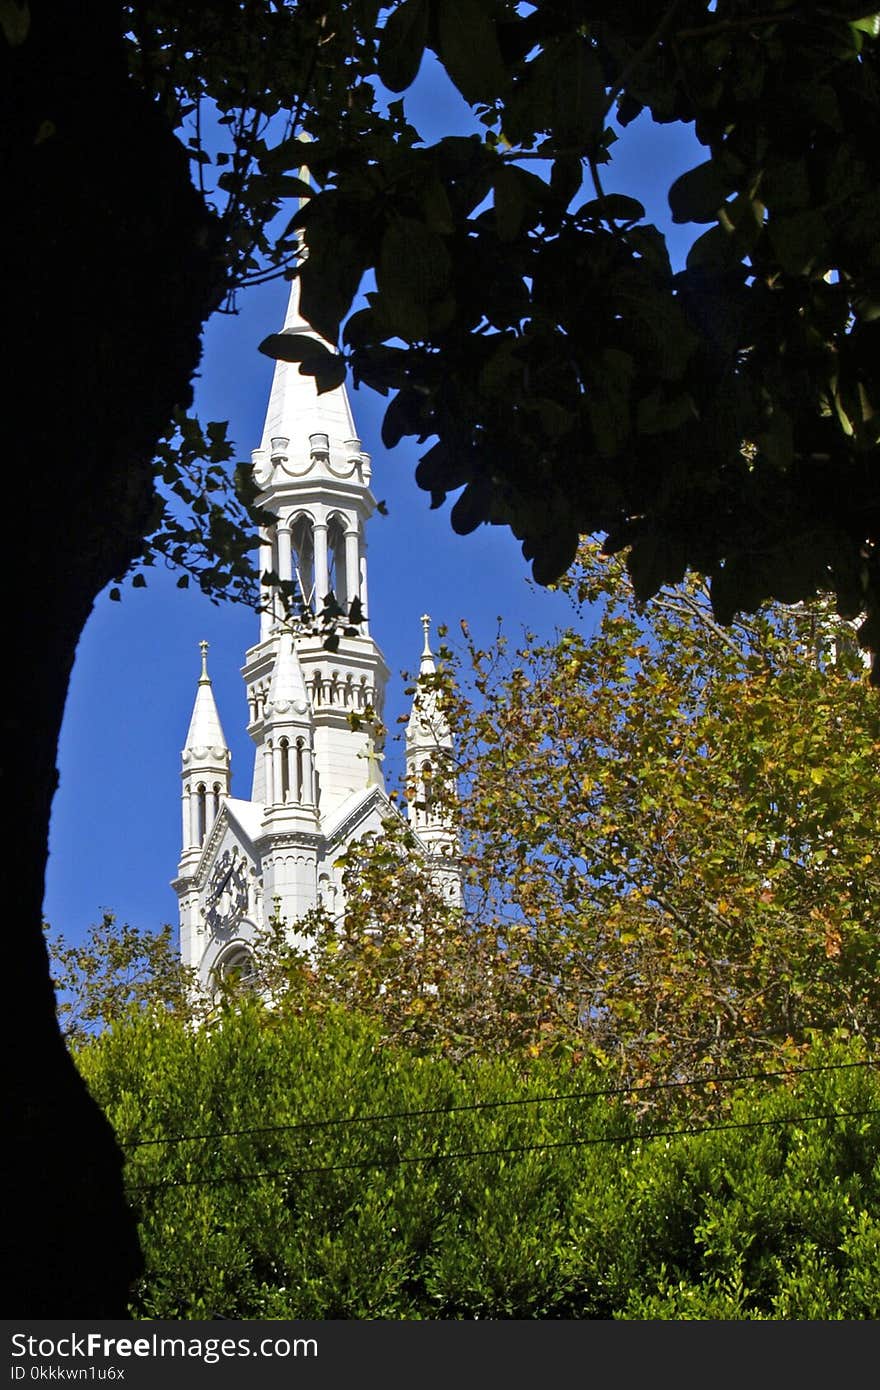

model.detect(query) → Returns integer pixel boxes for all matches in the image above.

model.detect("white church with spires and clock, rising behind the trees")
[174,282,457,990]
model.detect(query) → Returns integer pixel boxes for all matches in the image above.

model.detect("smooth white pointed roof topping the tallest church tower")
[260,279,357,456]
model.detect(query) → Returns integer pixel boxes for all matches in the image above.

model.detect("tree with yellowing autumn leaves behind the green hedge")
[300,546,880,1079]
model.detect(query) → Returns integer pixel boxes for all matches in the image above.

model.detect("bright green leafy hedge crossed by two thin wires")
[79,1008,880,1321]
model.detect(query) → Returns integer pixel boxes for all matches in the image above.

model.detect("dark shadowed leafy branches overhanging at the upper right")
[279,0,880,672]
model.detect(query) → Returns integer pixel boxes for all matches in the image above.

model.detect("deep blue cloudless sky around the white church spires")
[44,74,701,940]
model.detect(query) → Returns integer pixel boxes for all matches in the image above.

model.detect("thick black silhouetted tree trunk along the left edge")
[0,0,221,1318]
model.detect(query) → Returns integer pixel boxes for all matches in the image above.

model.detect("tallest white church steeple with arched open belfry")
[243,281,388,817]
